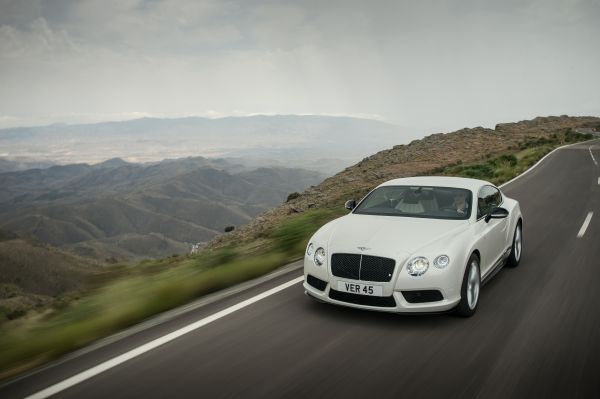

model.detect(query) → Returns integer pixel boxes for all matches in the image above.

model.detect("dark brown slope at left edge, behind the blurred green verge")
[0,229,102,323]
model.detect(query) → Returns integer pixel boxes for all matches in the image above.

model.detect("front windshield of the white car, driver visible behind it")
[354,186,472,219]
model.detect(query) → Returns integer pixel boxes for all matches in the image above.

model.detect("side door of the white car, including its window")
[477,185,508,276]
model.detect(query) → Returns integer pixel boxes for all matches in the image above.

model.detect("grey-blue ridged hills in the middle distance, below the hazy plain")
[0,157,325,260]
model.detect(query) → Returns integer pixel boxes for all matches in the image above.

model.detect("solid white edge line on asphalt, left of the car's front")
[27,276,304,399]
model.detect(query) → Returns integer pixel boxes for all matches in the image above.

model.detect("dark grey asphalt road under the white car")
[0,140,600,399]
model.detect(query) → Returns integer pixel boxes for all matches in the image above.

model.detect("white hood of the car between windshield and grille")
[328,214,469,257]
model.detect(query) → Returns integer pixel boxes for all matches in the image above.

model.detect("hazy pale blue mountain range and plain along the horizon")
[0,115,418,174]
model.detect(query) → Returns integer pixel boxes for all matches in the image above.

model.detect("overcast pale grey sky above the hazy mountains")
[0,0,600,131]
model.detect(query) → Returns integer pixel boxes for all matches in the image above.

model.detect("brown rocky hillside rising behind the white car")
[209,115,600,248]
